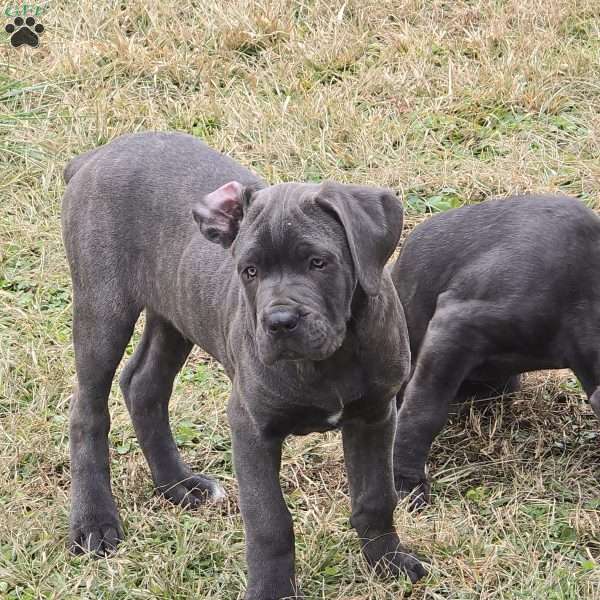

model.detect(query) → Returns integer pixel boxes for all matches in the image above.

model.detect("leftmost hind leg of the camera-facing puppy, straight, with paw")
[69,291,139,554]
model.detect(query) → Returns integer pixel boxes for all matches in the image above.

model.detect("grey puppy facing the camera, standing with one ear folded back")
[63,133,424,600]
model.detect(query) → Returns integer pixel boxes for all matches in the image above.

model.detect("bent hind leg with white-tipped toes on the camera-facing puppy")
[120,311,224,507]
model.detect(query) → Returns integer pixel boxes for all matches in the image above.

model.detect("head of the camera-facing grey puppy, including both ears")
[193,182,402,364]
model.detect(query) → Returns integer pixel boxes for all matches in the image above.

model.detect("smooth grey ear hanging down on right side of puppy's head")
[316,182,403,296]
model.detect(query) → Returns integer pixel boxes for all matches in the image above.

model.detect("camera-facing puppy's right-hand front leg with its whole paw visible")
[342,401,426,583]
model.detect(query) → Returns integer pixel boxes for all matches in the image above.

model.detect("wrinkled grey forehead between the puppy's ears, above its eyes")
[234,183,346,255]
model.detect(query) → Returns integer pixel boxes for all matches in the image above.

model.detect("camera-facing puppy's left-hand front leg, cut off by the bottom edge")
[228,394,297,600]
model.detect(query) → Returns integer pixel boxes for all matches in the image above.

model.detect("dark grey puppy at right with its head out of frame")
[392,196,600,506]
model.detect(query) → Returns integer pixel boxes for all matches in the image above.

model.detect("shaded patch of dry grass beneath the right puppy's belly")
[429,373,600,496]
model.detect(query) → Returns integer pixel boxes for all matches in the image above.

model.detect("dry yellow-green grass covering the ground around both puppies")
[0,0,600,600]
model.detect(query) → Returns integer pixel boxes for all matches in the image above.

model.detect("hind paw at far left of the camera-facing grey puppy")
[69,514,123,556]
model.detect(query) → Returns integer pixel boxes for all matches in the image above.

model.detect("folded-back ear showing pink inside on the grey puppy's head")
[192,181,259,248]
